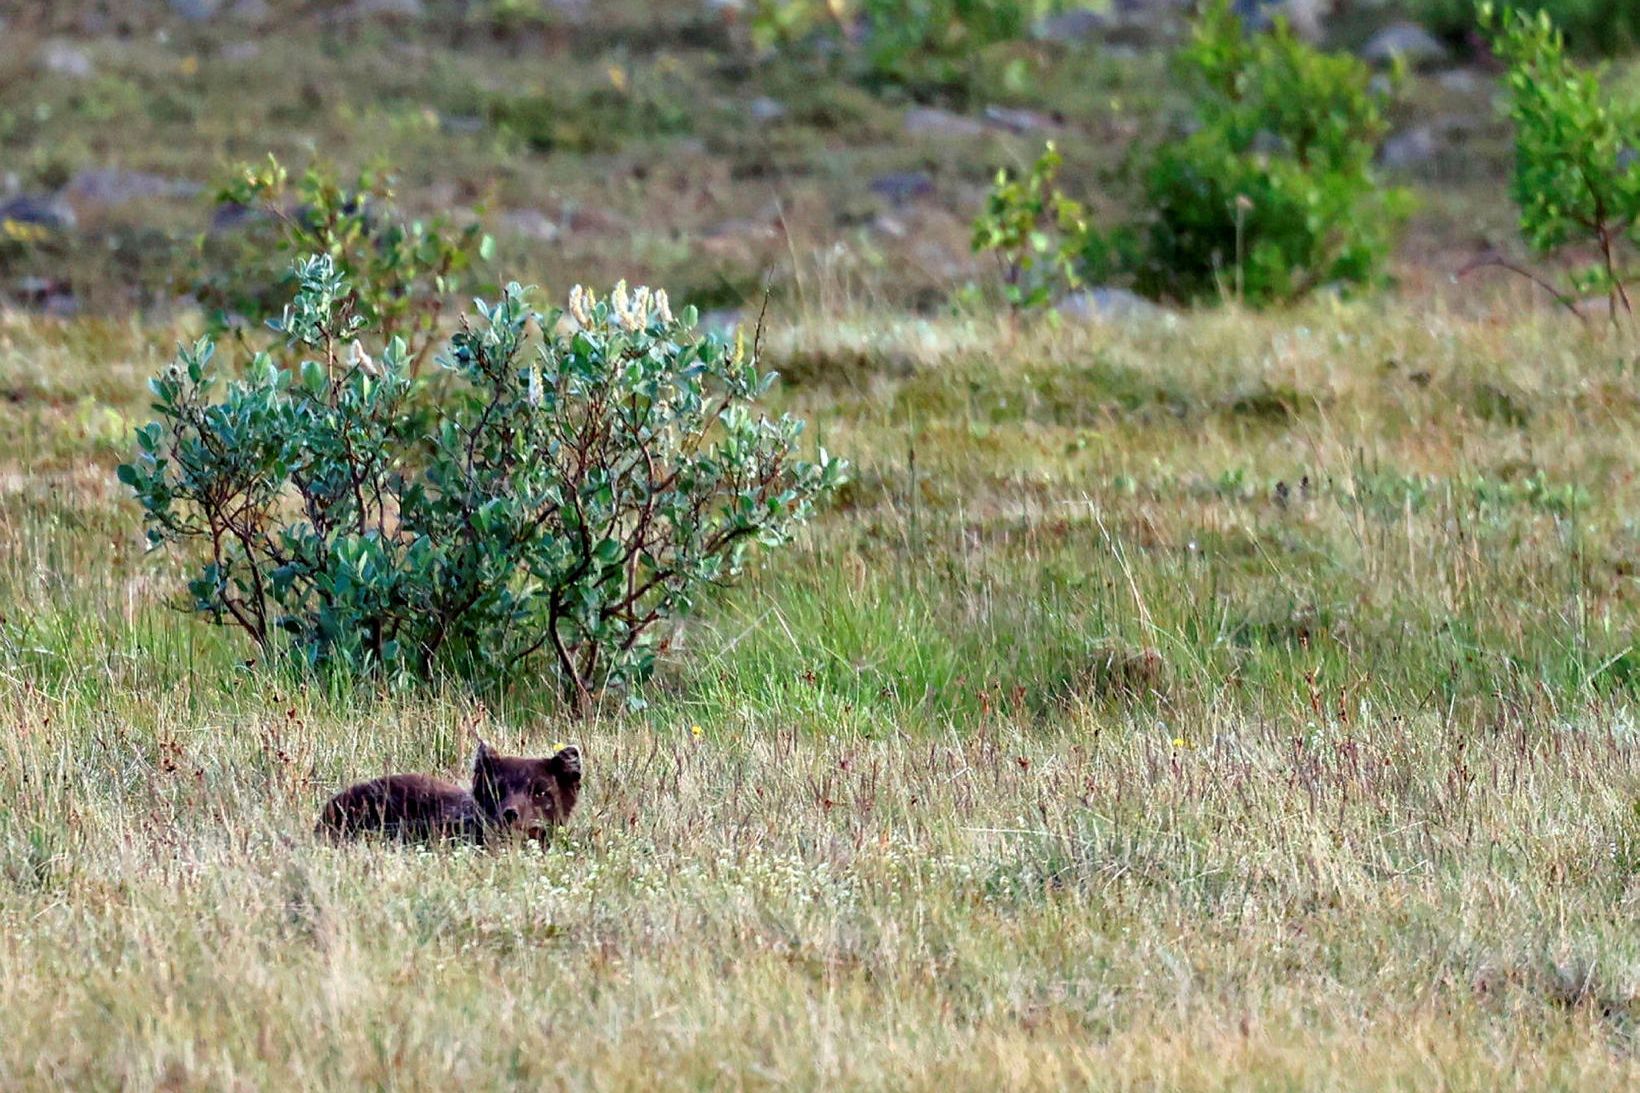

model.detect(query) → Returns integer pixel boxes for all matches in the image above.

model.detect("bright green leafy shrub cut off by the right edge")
[1481,5,1640,317]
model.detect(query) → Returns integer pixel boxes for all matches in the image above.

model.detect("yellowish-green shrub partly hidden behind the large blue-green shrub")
[194,156,494,371]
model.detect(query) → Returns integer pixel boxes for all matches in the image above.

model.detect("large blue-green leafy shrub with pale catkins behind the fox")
[120,254,845,709]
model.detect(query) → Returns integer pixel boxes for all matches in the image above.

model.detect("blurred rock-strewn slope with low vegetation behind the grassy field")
[0,0,1607,323]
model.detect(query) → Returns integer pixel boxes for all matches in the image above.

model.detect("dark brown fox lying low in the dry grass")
[313,740,581,844]
